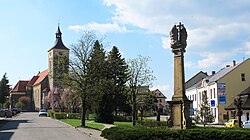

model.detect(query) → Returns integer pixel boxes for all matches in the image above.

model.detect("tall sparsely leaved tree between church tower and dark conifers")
[67,31,96,127]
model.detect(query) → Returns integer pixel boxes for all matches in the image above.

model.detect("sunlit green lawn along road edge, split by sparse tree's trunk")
[60,119,104,130]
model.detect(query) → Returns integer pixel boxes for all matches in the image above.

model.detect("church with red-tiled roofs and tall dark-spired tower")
[10,26,69,111]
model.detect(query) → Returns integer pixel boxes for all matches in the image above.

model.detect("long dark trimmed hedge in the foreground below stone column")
[101,126,250,140]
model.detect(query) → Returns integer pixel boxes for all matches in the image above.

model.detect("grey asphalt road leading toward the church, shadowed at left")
[0,112,93,140]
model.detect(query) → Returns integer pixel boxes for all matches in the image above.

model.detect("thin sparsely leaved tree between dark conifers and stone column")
[128,55,155,126]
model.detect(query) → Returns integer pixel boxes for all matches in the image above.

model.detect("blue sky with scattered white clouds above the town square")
[0,0,250,99]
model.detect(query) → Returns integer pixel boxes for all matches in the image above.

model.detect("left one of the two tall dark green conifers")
[87,40,114,123]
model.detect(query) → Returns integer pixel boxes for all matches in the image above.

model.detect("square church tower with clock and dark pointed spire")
[48,25,69,89]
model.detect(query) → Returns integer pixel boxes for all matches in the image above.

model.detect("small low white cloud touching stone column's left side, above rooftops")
[150,84,174,100]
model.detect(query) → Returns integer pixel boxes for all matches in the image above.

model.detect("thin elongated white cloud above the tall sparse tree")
[69,22,129,34]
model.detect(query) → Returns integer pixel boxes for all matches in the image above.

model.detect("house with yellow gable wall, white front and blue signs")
[186,59,250,123]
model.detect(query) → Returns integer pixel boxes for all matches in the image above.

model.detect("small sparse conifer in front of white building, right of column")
[197,94,214,127]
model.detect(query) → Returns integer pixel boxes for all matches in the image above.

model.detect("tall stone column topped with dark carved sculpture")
[168,23,191,129]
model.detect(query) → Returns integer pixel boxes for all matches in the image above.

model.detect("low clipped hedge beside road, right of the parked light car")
[48,110,80,119]
